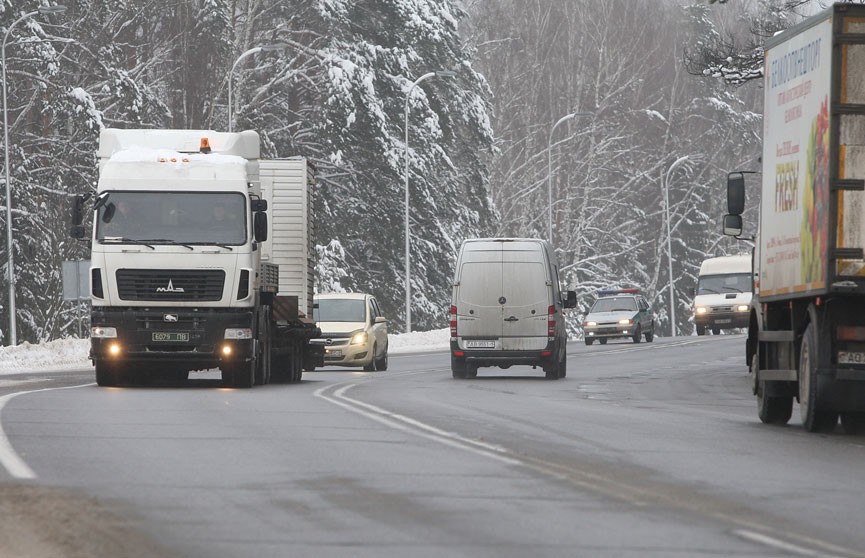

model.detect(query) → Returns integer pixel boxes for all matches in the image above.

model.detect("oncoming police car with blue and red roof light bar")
[583,289,655,345]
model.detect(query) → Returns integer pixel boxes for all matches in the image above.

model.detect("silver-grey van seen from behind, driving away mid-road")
[450,238,577,380]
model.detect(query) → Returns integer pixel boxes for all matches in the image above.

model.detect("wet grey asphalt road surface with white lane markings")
[0,335,865,558]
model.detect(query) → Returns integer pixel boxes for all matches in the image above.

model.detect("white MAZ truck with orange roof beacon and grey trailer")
[72,129,323,388]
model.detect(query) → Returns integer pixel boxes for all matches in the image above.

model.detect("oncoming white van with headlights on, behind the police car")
[694,255,754,335]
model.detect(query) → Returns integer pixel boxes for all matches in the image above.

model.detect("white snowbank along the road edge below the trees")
[0,328,450,375]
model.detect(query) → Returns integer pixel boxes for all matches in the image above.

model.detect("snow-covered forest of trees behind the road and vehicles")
[0,0,836,344]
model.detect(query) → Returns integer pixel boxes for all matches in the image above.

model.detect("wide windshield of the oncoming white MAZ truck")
[96,191,247,246]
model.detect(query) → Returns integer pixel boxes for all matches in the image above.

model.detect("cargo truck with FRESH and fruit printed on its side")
[724,4,865,433]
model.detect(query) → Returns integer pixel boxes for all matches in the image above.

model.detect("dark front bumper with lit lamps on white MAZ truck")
[90,308,255,370]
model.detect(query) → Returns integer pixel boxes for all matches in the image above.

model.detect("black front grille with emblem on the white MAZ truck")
[116,269,225,301]
